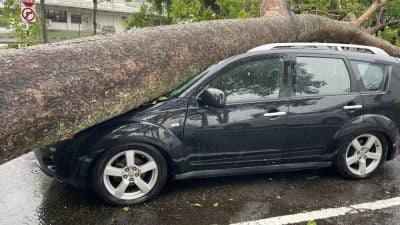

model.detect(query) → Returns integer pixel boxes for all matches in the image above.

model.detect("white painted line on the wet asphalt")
[232,197,400,225]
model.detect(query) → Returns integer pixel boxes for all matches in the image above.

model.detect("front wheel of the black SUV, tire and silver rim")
[91,144,168,205]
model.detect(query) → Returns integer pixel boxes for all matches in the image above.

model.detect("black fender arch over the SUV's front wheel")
[70,120,186,186]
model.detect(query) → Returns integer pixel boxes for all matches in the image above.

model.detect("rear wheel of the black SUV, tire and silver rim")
[335,132,388,179]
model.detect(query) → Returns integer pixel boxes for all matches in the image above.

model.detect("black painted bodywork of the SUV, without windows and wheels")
[36,49,400,187]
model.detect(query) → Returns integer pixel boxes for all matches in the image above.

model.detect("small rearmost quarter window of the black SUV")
[351,61,386,91]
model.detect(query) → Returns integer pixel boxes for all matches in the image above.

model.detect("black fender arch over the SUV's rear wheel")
[332,114,400,160]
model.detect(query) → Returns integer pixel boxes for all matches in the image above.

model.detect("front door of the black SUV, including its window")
[184,54,290,170]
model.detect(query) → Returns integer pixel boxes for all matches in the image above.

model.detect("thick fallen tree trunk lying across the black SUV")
[0,7,400,162]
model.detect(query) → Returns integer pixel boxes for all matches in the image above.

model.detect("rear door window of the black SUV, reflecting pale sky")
[294,57,350,96]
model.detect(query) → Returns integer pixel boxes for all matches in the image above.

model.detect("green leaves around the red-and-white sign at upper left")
[0,0,40,45]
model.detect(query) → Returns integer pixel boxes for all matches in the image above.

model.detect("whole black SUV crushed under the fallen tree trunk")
[35,44,400,205]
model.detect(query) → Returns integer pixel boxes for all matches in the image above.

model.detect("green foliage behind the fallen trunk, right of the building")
[126,0,400,44]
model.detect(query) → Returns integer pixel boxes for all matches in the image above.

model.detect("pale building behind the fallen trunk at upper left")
[0,0,144,43]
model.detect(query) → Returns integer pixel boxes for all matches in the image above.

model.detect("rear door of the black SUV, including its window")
[283,54,363,163]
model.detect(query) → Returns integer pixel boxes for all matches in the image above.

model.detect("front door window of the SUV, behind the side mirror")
[210,57,284,103]
